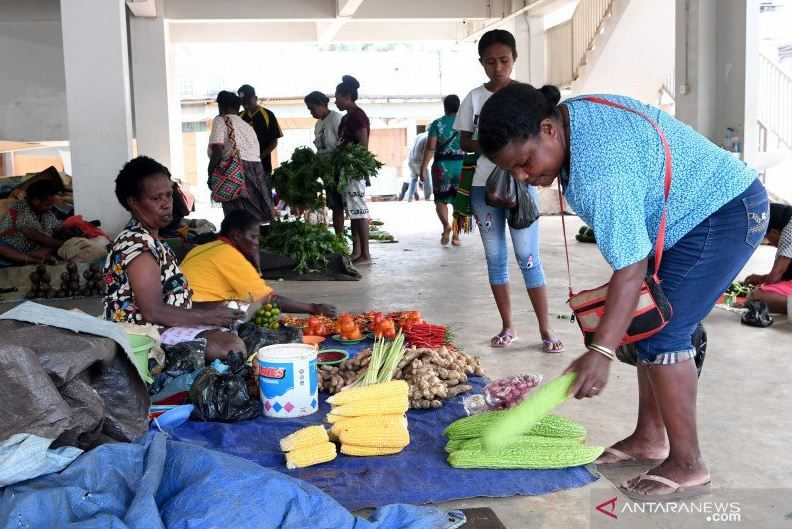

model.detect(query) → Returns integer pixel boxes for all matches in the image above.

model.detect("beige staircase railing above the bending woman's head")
[547,0,614,85]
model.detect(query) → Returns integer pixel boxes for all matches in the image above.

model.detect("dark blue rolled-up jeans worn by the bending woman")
[636,180,769,364]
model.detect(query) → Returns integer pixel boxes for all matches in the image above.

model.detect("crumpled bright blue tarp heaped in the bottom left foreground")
[0,433,447,529]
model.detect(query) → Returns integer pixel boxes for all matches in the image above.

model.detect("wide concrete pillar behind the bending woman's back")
[676,0,759,158]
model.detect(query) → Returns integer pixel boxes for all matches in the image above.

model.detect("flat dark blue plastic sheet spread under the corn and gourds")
[168,378,597,510]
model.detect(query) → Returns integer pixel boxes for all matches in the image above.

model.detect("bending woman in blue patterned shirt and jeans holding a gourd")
[479,83,768,501]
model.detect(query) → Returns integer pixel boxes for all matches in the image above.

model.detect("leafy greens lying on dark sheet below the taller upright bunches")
[261,220,349,274]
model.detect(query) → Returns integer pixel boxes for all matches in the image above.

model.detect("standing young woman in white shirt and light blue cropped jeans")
[454,29,564,353]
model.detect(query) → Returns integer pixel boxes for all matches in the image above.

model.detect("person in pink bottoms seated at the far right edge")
[745,204,792,314]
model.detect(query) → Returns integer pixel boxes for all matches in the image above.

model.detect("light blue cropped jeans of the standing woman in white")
[470,186,545,288]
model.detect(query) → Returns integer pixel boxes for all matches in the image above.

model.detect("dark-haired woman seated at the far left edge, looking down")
[0,180,63,265]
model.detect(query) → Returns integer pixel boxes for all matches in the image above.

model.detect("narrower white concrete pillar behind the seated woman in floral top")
[129,2,184,178]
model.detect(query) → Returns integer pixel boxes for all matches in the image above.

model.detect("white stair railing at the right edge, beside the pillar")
[757,53,792,149]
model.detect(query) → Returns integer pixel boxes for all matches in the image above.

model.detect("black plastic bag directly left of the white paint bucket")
[190,352,261,422]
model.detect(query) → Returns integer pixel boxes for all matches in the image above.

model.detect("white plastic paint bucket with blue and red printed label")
[256,343,319,419]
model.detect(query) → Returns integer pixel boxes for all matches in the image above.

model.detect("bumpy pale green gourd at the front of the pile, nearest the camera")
[448,446,604,469]
